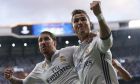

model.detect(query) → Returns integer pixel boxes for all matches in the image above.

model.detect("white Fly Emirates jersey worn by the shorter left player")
[23,46,79,84]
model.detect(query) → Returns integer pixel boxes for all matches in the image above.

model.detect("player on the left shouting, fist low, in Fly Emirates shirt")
[4,31,79,84]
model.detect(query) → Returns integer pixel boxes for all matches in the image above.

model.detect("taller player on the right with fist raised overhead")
[72,1,118,84]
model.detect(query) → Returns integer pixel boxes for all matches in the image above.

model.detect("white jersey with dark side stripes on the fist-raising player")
[74,35,119,84]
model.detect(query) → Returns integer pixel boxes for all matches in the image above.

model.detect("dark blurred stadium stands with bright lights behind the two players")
[0,25,140,84]
